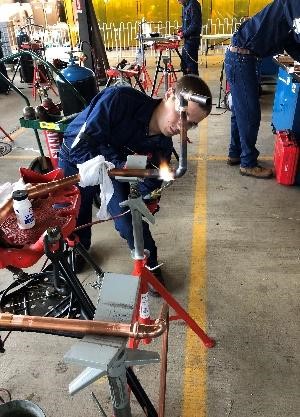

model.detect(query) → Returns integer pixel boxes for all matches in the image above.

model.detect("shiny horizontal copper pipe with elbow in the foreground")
[0,304,168,339]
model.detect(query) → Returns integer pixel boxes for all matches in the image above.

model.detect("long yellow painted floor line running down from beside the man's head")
[181,115,207,417]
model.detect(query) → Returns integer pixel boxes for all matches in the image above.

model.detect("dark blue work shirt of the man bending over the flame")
[64,86,172,168]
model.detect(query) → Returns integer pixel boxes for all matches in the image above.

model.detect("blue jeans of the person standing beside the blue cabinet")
[225,49,261,168]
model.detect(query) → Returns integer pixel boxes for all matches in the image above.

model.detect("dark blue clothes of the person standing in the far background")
[181,0,202,75]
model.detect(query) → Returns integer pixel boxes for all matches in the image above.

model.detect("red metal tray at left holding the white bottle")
[0,168,80,268]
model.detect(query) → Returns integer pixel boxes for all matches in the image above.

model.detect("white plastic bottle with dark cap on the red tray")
[12,190,35,229]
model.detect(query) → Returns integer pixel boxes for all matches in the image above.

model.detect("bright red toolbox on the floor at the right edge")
[274,130,299,185]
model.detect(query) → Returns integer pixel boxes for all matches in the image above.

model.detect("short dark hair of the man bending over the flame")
[174,74,212,114]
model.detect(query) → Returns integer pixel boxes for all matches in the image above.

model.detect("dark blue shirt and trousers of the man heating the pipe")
[59,87,173,267]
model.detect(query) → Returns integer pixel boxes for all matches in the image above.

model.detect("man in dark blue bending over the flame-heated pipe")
[59,75,211,292]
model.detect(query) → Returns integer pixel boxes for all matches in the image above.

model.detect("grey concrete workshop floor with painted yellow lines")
[0,55,300,417]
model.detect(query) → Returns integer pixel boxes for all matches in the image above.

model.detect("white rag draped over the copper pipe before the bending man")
[77,155,115,220]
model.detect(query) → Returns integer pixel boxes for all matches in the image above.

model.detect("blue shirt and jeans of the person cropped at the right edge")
[225,0,300,168]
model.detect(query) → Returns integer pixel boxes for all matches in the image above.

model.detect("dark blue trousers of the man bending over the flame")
[58,147,160,268]
